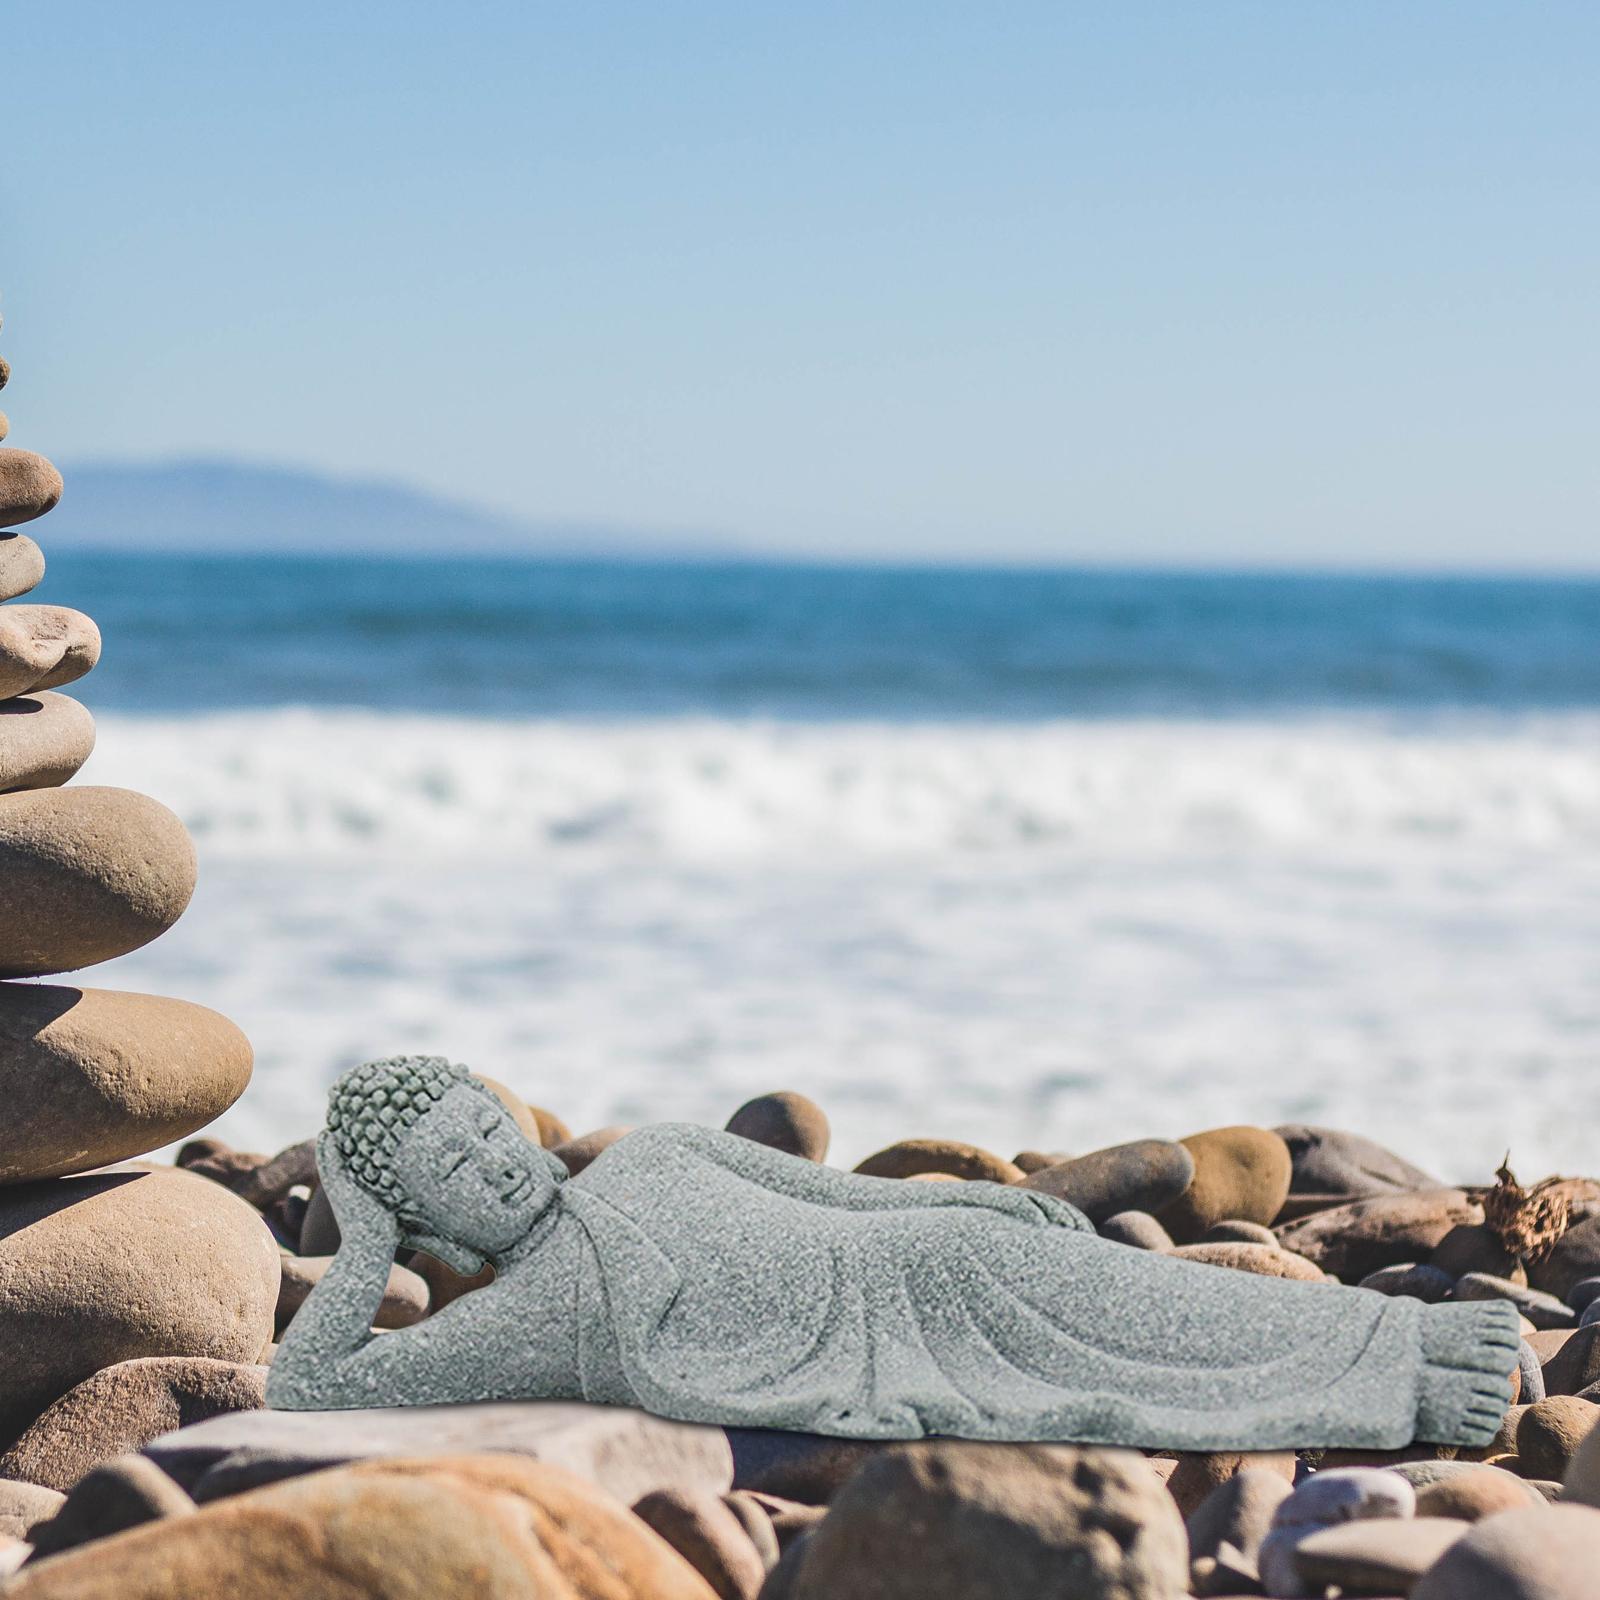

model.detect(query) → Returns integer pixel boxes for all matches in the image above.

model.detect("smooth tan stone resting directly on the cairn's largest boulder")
[0,982,253,1184]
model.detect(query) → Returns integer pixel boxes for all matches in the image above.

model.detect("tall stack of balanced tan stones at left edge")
[0,321,280,1571]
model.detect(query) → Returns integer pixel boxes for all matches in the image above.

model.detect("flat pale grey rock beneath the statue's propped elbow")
[144,1400,733,1506]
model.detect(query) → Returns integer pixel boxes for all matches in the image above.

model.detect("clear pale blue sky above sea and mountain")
[0,0,1600,566]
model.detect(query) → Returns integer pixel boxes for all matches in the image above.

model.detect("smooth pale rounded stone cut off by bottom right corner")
[1411,1506,1600,1600]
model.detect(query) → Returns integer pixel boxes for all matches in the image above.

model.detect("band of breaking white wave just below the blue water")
[85,710,1600,859]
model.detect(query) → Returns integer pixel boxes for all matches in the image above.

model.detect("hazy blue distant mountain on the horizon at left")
[48,461,736,557]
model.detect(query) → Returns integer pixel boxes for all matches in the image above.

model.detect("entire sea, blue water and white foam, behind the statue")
[37,554,1600,1179]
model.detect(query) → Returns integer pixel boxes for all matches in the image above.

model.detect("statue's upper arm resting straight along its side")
[619,1122,1090,1230]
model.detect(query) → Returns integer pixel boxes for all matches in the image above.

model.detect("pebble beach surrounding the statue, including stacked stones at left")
[0,370,1600,1600]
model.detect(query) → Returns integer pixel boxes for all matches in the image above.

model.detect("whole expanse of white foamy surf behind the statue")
[72,710,1600,1179]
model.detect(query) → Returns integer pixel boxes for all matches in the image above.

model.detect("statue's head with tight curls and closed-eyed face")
[328,1056,566,1274]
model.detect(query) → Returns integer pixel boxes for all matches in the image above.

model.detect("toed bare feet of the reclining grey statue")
[1416,1301,1522,1448]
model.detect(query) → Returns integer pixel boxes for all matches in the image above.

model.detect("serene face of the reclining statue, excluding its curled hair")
[392,1083,555,1270]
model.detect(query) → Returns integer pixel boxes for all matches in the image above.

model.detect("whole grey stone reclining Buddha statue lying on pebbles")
[265,1056,1518,1459]
